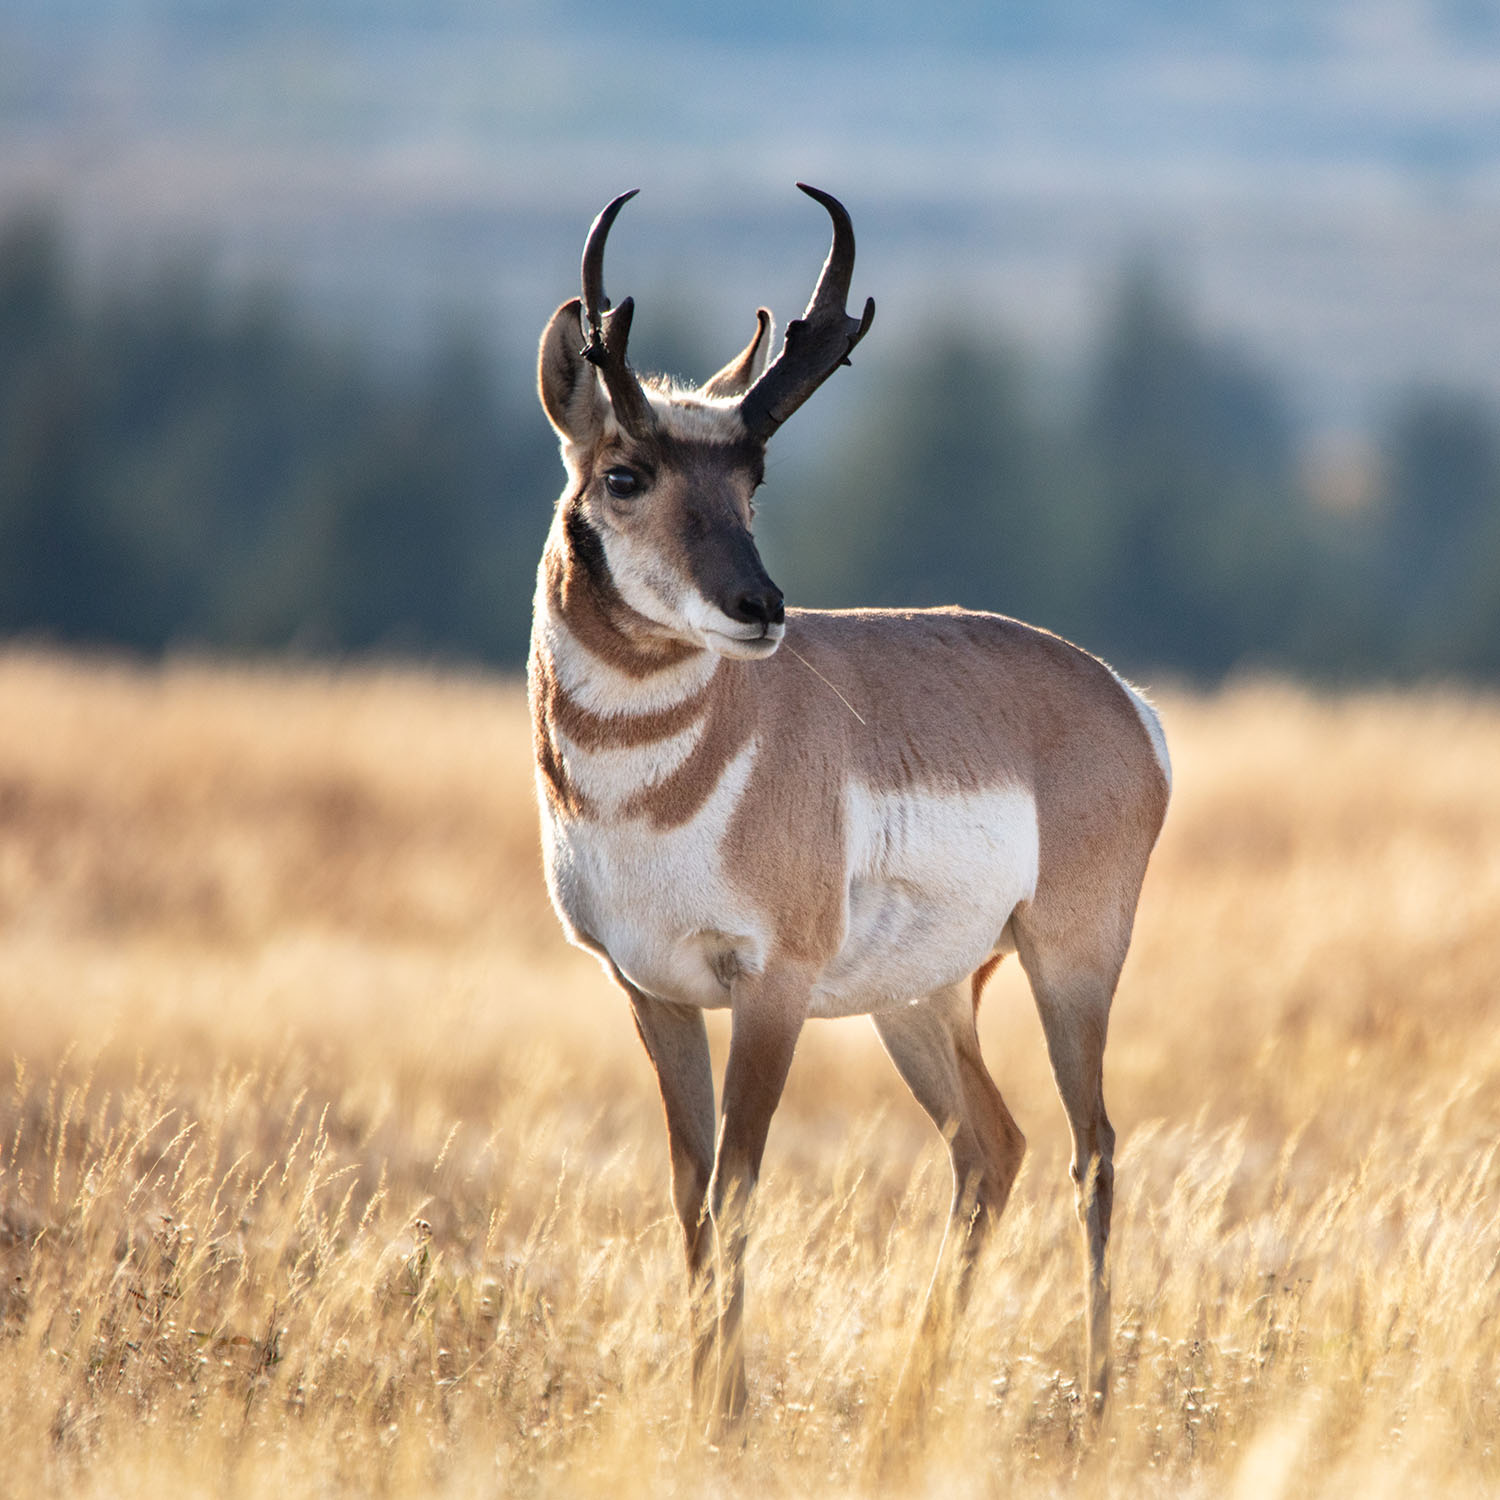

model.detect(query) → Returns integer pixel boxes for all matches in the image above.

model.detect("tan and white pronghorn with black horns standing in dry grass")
[528,185,1170,1425]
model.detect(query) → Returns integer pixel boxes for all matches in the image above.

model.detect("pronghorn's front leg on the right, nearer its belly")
[710,975,807,1427]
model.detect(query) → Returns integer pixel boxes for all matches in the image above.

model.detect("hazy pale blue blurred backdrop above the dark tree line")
[0,0,1500,425]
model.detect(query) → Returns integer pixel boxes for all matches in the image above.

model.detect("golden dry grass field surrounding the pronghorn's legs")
[0,653,1500,1500]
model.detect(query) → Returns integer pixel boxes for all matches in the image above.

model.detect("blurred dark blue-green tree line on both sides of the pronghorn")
[0,215,1500,681]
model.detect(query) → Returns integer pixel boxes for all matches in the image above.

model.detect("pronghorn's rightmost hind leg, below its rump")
[1019,933,1119,1416]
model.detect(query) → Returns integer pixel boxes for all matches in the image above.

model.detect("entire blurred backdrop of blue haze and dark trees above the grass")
[0,0,1500,683]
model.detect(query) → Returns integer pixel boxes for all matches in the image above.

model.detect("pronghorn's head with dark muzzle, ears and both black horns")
[539,183,875,660]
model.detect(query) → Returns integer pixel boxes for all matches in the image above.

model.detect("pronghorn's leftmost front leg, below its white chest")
[617,975,719,1422]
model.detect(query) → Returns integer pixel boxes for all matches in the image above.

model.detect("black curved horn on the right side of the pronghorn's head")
[740,183,875,443]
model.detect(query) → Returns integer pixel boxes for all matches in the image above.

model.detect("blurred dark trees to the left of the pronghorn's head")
[0,216,557,662]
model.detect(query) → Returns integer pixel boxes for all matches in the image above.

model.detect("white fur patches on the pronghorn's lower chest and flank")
[543,746,1038,1017]
